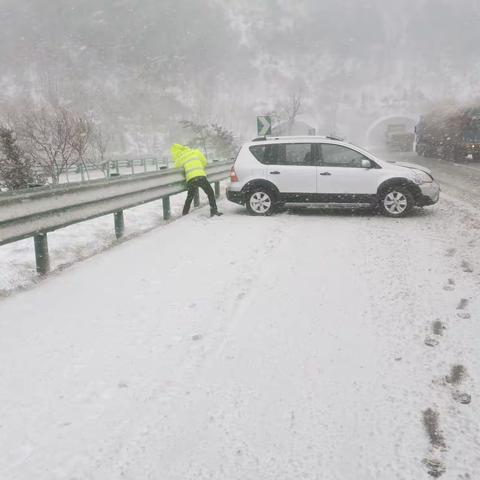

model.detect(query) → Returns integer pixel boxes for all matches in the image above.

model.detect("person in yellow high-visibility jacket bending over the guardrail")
[170,143,222,217]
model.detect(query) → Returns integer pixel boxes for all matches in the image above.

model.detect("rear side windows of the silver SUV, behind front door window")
[250,143,314,165]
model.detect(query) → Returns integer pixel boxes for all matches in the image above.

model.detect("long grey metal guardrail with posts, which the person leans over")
[0,161,232,274]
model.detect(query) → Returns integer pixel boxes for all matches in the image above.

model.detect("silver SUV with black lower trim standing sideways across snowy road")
[227,136,440,217]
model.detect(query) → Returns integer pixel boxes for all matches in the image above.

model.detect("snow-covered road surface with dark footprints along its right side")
[0,163,480,480]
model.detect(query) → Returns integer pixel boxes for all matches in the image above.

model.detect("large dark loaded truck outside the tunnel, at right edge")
[415,106,480,162]
